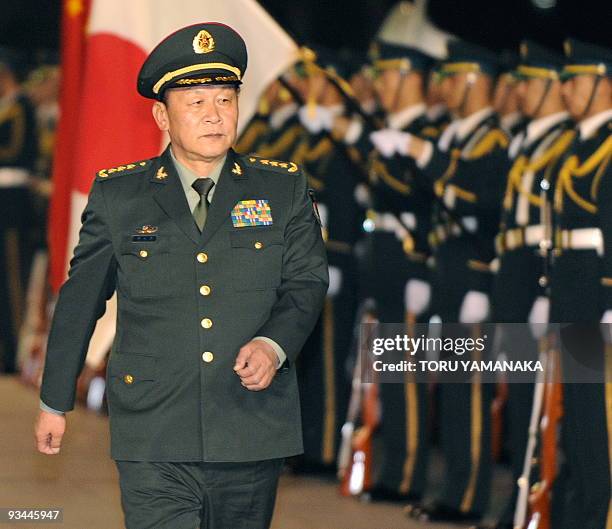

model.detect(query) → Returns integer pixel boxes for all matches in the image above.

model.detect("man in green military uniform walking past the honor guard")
[36,23,328,529]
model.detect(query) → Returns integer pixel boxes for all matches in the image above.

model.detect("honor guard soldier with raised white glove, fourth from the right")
[334,41,432,502]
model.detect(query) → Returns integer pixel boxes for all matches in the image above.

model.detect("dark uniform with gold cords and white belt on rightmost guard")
[551,112,612,529]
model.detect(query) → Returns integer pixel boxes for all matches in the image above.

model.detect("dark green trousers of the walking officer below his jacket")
[115,458,283,529]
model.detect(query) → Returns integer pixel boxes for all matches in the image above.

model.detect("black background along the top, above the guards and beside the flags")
[0,0,612,62]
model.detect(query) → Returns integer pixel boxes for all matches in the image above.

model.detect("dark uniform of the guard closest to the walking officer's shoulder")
[293,126,361,470]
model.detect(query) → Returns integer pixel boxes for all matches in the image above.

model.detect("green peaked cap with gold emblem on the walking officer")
[138,22,248,100]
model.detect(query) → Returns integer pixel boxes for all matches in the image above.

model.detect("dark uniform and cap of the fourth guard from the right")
[344,42,440,501]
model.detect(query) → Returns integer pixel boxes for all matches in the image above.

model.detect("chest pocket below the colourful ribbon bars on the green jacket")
[230,228,284,292]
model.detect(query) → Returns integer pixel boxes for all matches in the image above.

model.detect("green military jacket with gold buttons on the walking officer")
[41,145,328,461]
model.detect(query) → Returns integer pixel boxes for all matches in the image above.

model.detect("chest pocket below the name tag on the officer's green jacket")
[119,235,172,298]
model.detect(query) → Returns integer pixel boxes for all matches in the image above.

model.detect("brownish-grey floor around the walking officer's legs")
[0,376,509,529]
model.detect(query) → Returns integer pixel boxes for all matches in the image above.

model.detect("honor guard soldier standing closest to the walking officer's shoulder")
[293,48,362,472]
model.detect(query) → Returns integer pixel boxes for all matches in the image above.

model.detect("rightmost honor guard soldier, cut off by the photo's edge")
[551,39,612,529]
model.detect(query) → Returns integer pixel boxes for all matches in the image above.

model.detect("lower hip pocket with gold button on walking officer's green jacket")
[107,353,159,411]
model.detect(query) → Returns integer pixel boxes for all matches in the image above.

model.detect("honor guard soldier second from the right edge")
[482,41,574,529]
